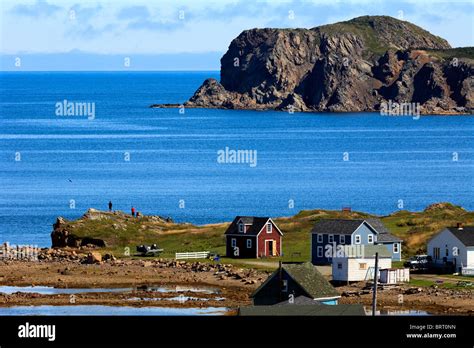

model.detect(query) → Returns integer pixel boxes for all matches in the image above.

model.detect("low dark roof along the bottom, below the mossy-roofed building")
[239,304,365,316]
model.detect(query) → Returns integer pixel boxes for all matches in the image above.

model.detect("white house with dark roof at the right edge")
[427,224,474,275]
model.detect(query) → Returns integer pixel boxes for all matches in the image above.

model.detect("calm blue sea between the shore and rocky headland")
[0,72,474,246]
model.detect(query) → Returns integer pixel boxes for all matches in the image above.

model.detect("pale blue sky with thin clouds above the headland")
[0,0,474,70]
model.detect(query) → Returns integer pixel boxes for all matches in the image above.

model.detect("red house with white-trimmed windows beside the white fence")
[225,216,283,258]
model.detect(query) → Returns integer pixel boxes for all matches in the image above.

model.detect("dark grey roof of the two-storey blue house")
[311,218,401,242]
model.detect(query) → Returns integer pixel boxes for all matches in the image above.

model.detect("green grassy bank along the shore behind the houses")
[56,203,474,261]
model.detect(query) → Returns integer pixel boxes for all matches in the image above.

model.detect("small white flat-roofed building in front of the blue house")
[332,245,392,282]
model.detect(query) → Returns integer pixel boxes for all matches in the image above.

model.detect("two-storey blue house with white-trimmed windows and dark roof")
[311,218,402,265]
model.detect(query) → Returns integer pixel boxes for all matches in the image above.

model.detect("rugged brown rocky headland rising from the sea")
[180,16,474,113]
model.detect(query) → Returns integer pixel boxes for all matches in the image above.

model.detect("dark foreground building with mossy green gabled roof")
[252,262,341,306]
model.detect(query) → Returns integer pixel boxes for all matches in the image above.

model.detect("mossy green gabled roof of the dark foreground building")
[252,262,341,299]
